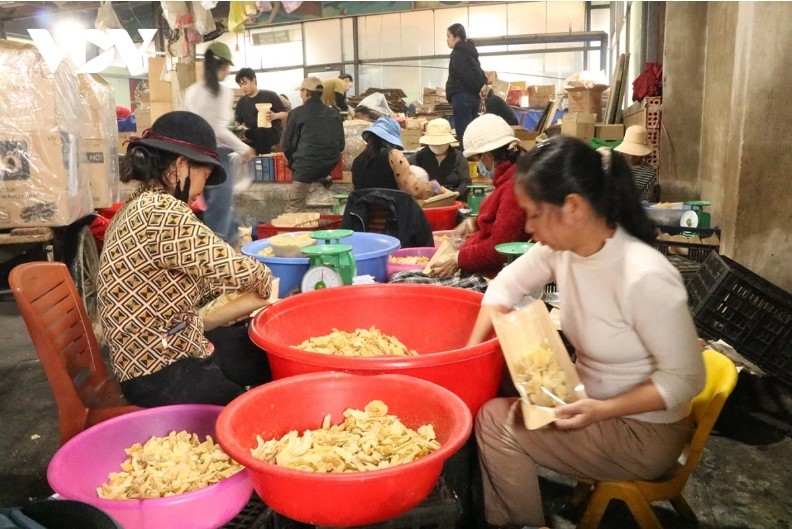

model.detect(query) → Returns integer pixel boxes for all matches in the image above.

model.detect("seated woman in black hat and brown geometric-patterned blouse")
[97,111,272,407]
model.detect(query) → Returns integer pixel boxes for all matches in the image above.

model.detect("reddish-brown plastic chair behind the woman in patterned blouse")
[8,262,141,444]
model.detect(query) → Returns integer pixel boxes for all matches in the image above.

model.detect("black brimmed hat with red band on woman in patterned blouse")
[129,110,226,186]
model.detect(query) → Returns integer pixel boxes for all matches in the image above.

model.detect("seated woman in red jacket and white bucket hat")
[389,114,528,292]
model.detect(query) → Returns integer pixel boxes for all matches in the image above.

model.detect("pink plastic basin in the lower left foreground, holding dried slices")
[47,404,253,529]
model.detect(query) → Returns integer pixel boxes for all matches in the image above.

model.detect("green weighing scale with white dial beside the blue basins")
[300,230,357,292]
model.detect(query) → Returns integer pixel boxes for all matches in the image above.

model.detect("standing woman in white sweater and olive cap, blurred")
[184,42,256,246]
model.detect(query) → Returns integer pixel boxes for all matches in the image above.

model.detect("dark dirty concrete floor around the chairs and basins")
[0,295,792,529]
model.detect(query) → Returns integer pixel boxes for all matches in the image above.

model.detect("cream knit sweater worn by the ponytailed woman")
[482,228,705,423]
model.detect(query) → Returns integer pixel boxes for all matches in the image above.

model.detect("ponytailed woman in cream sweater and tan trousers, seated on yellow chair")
[470,138,705,527]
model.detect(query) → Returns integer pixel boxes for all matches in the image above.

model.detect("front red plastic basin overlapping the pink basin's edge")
[217,372,472,527]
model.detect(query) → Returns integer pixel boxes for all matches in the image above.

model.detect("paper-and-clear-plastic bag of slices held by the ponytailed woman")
[492,301,586,430]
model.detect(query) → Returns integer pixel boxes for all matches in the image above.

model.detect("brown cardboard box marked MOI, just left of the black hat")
[80,138,120,209]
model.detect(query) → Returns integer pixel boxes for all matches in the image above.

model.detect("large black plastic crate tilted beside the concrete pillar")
[687,252,792,384]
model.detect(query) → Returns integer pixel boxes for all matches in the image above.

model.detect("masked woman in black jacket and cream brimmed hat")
[407,118,470,202]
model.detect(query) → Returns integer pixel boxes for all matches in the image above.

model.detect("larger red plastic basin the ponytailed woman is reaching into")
[250,283,504,416]
